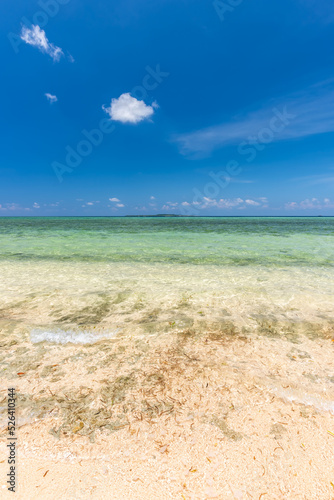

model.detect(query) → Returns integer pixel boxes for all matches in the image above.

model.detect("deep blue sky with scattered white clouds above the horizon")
[0,0,334,216]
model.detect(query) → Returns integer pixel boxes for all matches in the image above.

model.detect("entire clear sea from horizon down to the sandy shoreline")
[0,217,334,343]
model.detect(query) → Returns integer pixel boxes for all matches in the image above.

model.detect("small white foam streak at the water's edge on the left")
[30,329,119,344]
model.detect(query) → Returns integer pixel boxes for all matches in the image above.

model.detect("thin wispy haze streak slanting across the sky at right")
[174,80,334,155]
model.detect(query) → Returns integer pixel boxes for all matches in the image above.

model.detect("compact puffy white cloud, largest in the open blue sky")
[102,93,158,123]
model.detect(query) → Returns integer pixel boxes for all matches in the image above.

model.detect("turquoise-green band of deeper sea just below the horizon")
[0,217,334,267]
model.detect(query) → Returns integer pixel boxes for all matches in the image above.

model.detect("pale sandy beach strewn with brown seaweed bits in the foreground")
[0,323,334,500]
